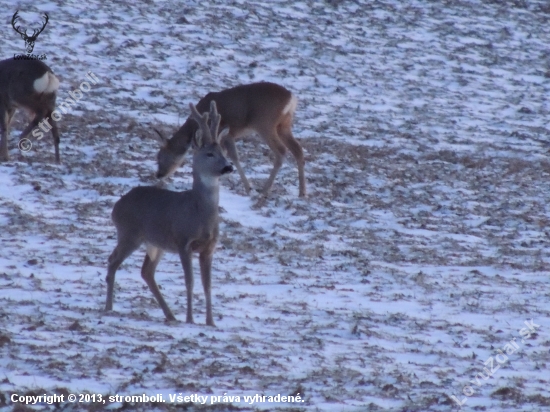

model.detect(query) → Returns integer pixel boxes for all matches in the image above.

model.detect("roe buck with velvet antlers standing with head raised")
[105,102,233,326]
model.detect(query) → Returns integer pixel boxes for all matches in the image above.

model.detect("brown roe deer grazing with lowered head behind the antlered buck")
[157,82,306,196]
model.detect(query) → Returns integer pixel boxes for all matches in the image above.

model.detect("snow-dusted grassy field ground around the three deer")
[0,0,550,411]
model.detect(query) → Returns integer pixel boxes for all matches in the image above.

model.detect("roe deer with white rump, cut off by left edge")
[0,59,59,163]
